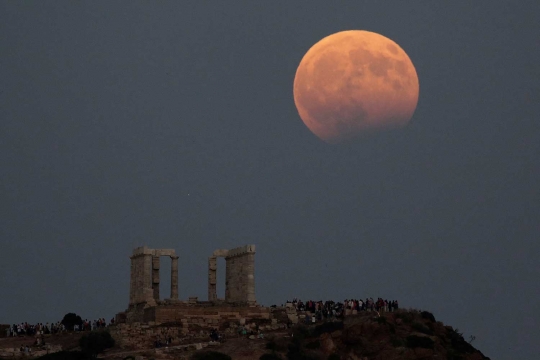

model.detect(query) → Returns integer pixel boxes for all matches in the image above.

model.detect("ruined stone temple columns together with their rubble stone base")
[109,245,298,348]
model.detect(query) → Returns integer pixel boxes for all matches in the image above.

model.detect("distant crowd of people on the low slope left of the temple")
[6,318,114,337]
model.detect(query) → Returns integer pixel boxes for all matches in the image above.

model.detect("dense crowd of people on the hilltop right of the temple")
[287,298,399,321]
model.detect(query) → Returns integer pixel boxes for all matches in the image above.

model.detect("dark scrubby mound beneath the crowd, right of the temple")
[260,310,488,360]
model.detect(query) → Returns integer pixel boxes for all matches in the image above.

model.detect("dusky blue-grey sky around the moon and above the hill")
[0,0,540,359]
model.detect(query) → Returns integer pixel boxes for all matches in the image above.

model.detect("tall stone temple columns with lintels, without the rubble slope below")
[121,245,256,323]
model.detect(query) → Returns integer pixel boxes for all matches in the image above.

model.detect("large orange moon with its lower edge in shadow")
[294,30,419,143]
